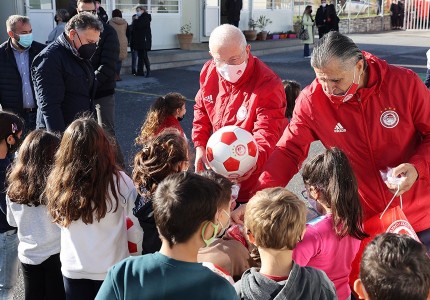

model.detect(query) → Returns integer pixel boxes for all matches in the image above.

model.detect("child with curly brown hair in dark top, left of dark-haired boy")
[133,129,189,254]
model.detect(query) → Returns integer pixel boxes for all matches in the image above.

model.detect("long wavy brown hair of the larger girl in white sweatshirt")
[46,118,120,227]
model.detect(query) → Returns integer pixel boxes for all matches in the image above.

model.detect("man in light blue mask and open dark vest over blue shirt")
[0,15,45,131]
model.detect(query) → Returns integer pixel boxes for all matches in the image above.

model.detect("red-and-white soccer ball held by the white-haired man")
[206,125,258,179]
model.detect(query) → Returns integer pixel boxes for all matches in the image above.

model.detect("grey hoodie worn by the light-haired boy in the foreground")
[234,262,337,300]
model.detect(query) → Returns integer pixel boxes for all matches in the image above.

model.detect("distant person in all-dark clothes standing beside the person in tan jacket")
[130,5,152,77]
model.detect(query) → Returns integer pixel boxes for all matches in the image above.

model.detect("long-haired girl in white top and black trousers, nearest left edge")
[6,130,65,299]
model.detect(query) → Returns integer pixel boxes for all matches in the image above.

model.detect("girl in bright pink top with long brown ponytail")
[293,148,367,300]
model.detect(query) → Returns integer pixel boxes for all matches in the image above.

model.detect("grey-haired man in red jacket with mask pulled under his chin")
[258,32,430,249]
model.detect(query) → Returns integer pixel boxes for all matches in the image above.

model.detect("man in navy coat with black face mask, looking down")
[31,13,103,132]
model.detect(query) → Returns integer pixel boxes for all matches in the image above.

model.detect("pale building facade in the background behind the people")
[0,0,294,50]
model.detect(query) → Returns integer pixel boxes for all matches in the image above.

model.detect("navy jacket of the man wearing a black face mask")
[31,33,96,132]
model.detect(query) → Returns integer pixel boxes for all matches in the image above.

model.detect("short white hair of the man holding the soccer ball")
[209,24,246,50]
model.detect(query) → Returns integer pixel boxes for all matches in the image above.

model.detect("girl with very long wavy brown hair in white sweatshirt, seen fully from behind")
[46,118,137,299]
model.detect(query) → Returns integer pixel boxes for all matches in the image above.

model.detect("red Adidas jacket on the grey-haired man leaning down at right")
[258,52,430,231]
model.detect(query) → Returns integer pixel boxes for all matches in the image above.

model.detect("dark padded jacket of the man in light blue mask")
[0,39,45,116]
